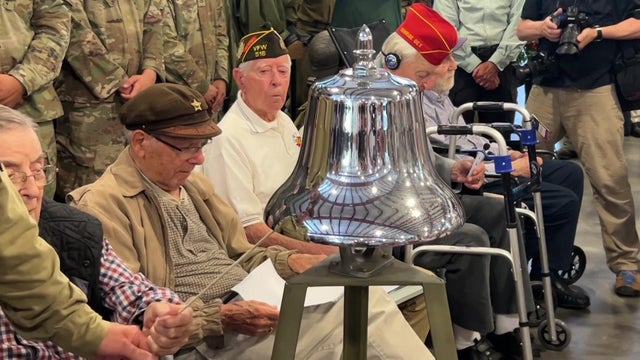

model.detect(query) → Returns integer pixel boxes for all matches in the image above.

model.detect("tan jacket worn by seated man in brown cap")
[67,147,293,336]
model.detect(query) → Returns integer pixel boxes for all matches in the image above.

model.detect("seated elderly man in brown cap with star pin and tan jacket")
[68,84,431,360]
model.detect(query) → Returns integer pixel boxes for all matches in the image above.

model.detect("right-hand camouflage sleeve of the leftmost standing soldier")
[9,0,71,95]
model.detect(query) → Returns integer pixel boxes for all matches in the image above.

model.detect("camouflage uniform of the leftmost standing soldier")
[0,0,71,195]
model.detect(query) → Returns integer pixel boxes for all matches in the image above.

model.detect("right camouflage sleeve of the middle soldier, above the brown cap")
[141,0,167,80]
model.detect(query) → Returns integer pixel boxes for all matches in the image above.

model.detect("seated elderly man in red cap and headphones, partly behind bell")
[379,4,532,359]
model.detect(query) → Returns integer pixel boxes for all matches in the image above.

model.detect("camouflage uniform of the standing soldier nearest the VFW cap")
[163,0,229,95]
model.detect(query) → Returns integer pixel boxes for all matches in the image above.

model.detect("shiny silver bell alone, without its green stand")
[265,26,464,248]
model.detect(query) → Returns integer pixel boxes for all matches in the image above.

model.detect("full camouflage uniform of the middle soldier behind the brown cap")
[56,0,166,196]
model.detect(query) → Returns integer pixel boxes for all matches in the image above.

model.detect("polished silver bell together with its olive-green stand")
[265,26,464,360]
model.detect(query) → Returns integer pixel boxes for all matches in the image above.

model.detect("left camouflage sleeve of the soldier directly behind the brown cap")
[66,0,127,99]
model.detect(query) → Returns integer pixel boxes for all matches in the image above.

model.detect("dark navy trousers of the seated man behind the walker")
[484,160,584,279]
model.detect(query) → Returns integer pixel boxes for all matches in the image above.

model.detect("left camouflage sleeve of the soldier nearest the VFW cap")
[162,1,209,94]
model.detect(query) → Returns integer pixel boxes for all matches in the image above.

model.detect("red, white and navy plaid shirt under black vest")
[0,239,181,360]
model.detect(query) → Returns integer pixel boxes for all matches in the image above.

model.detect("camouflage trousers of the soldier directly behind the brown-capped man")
[56,101,125,198]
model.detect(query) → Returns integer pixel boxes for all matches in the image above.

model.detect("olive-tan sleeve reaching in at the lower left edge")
[0,167,109,357]
